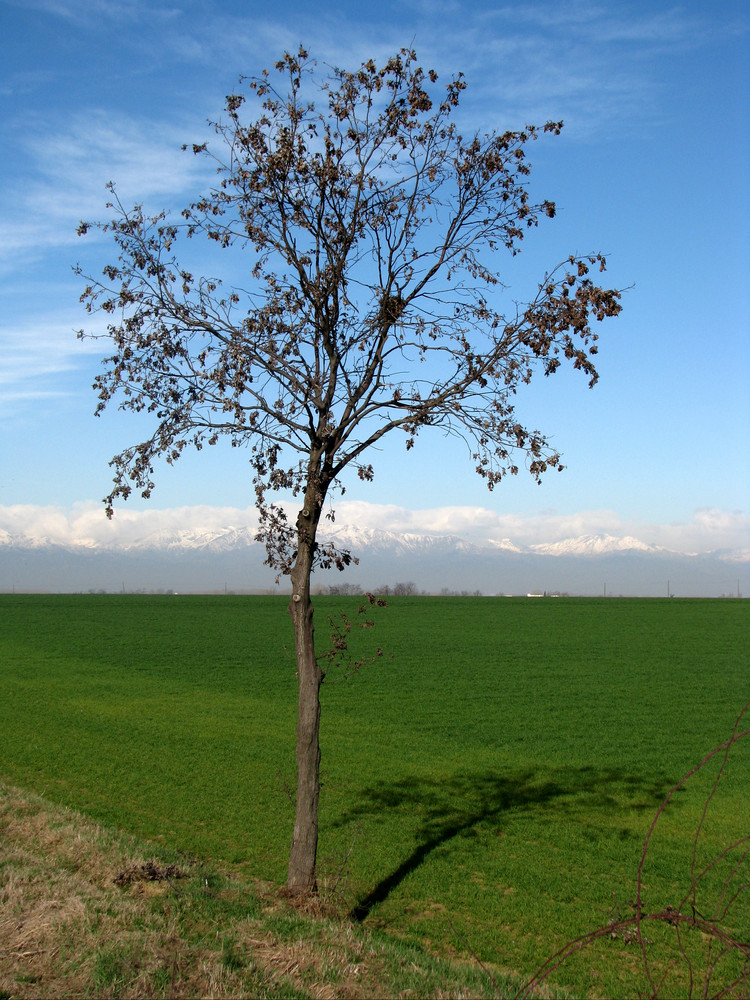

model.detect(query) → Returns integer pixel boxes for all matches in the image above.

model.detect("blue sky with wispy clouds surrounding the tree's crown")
[0,0,750,549]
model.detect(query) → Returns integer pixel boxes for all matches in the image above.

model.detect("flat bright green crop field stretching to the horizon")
[0,595,750,996]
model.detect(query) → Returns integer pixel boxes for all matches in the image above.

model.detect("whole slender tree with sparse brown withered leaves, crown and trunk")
[78,49,620,892]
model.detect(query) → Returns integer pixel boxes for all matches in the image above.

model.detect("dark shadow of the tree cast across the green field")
[344,767,673,923]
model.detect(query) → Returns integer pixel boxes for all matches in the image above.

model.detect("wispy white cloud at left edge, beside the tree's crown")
[0,102,213,412]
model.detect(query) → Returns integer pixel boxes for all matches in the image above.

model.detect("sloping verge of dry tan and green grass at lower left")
[0,786,528,1000]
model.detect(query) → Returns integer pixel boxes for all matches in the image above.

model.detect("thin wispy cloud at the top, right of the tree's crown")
[428,2,700,137]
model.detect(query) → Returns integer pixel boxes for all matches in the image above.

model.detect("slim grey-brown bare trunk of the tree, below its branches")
[287,489,323,893]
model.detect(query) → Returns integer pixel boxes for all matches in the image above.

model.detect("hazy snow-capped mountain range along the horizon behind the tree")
[0,525,750,596]
